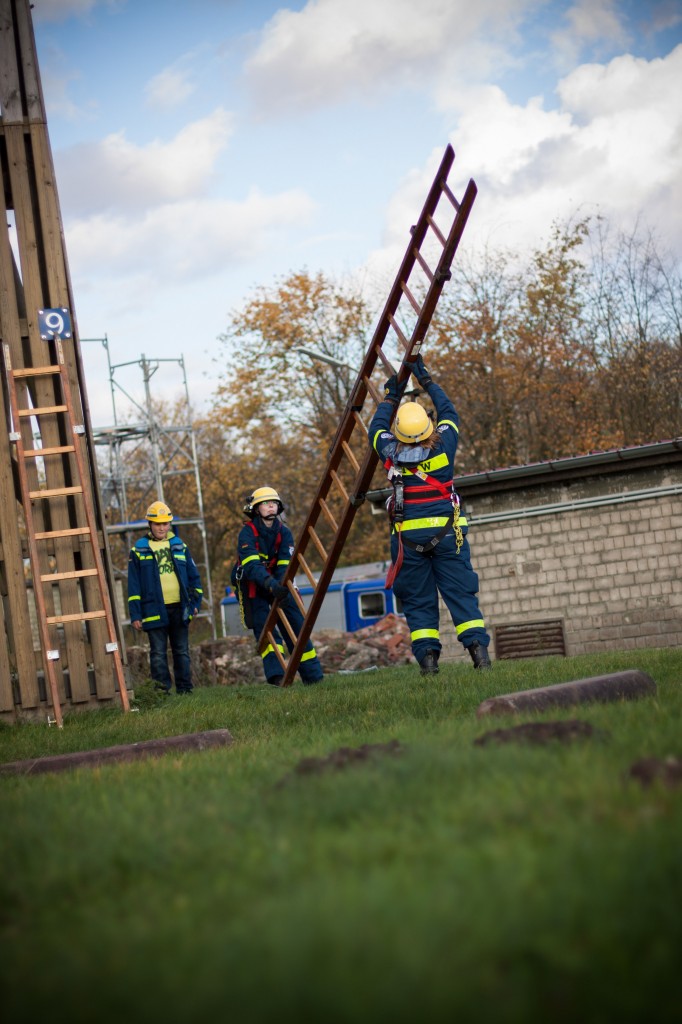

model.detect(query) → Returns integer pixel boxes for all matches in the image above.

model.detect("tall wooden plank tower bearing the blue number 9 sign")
[0,0,129,726]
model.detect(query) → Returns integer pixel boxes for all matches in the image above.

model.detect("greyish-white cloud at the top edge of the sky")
[246,0,531,111]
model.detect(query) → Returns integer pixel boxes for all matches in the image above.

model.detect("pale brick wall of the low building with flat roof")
[440,467,682,660]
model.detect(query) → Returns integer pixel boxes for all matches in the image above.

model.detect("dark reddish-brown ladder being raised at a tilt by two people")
[258,145,477,686]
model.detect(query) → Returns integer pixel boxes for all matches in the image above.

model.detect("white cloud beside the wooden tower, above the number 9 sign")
[55,109,233,216]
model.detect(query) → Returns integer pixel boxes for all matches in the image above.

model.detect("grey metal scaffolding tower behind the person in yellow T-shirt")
[81,335,217,639]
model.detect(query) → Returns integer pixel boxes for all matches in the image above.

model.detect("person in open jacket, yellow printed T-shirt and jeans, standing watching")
[128,502,204,693]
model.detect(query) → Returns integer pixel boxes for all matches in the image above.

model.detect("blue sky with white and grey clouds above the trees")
[33,0,682,426]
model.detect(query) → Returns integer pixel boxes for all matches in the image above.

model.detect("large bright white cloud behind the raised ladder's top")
[371,46,682,265]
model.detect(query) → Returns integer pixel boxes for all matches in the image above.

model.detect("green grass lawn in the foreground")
[0,649,682,1024]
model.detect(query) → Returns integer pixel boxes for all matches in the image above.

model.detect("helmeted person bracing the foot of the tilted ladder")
[232,487,324,686]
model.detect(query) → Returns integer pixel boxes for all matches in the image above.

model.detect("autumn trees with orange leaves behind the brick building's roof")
[424,219,682,472]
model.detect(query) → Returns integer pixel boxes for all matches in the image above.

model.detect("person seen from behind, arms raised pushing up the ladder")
[370,355,491,675]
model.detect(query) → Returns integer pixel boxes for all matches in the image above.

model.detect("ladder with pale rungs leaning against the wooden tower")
[3,337,130,728]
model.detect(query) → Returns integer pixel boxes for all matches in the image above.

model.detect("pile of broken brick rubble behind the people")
[127,614,413,686]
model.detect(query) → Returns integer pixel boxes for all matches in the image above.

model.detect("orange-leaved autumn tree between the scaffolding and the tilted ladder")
[201,271,387,581]
